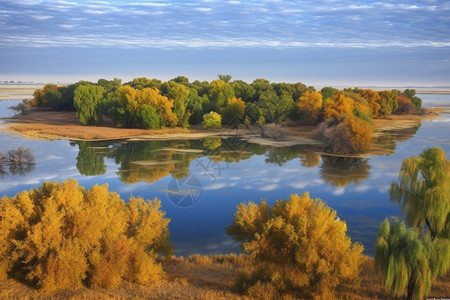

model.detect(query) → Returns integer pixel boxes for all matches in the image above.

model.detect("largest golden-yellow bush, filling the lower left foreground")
[0,179,170,291]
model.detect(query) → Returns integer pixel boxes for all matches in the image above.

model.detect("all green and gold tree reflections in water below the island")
[70,120,419,186]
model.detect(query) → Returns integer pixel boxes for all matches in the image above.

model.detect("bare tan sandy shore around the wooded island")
[3,108,446,147]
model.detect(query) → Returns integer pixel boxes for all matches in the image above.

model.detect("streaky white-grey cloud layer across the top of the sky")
[0,0,450,49]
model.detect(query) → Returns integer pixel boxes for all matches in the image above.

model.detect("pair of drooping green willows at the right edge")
[375,147,450,299]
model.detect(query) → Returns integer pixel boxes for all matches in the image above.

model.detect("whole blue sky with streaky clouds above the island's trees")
[0,0,450,86]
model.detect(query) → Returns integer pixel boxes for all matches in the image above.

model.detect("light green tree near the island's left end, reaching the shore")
[73,85,105,125]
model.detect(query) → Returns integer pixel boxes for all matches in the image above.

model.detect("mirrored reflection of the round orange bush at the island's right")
[320,155,370,186]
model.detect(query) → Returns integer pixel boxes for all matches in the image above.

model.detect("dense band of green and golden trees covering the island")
[31,75,422,153]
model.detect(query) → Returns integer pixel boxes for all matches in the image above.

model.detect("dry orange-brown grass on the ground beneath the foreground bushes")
[0,254,450,300]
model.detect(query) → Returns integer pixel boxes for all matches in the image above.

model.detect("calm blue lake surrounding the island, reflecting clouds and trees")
[0,95,450,256]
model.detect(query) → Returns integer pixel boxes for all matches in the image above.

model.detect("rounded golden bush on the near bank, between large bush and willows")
[227,193,365,298]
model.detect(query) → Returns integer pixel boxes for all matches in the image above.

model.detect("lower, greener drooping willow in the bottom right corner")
[375,219,450,300]
